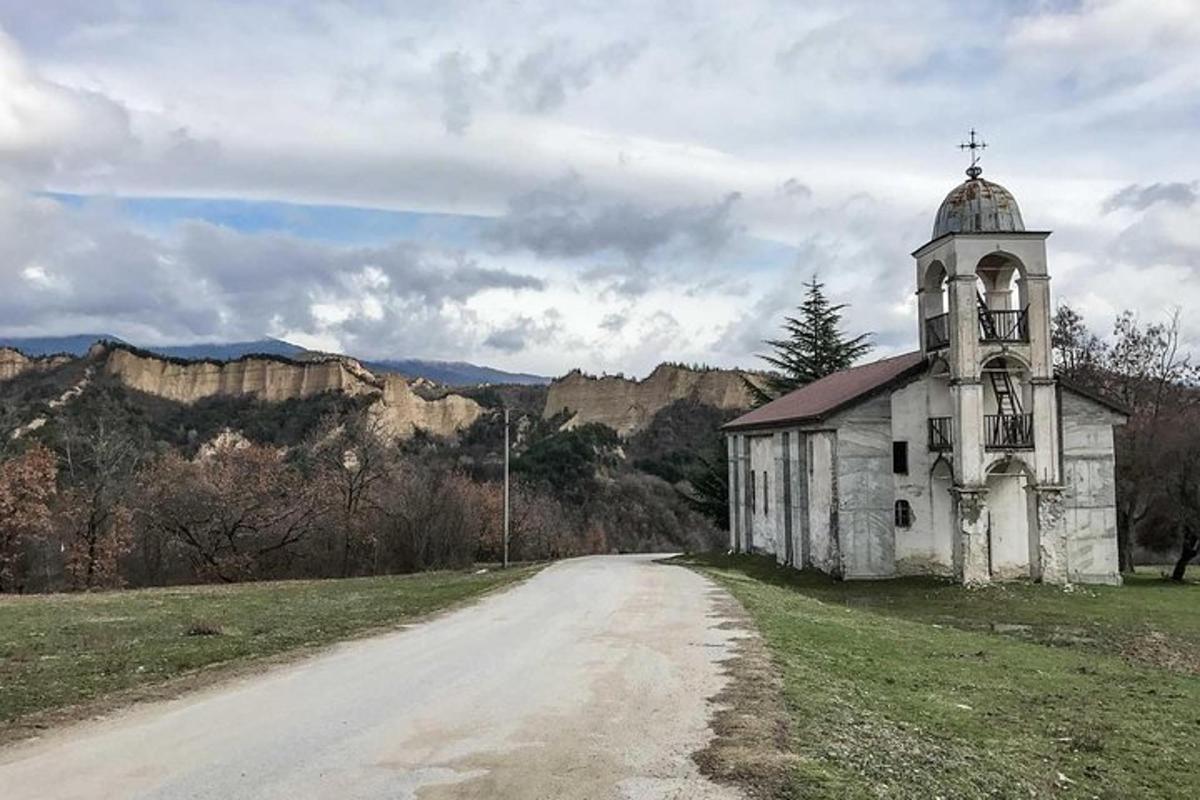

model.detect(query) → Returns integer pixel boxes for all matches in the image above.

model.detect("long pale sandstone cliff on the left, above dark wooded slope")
[96,344,484,437]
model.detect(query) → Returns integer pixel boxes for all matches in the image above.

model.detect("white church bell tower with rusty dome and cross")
[913,131,1066,583]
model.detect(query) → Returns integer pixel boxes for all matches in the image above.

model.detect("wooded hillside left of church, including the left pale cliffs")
[0,345,730,591]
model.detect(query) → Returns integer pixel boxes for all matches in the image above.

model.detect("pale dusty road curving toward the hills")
[0,557,740,800]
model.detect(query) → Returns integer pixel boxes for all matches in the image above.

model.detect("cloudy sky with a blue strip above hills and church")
[0,0,1200,375]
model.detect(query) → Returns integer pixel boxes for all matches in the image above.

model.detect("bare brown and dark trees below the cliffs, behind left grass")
[0,383,712,593]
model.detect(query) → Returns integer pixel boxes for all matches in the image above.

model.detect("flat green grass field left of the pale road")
[0,567,535,738]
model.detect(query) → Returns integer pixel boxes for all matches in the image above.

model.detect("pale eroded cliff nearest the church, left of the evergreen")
[542,363,754,435]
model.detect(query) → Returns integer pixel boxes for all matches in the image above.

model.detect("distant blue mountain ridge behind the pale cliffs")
[0,333,551,386]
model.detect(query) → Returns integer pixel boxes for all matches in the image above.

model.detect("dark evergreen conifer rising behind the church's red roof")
[746,275,872,405]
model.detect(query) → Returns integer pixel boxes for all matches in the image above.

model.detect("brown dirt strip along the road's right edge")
[692,593,799,799]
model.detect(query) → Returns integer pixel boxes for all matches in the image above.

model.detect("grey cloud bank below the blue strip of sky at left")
[0,193,545,355]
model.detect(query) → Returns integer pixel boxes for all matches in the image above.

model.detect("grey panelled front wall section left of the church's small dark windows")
[830,395,895,578]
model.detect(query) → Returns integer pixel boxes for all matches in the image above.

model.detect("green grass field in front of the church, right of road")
[686,557,1200,800]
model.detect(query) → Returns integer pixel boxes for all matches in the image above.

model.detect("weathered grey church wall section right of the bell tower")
[1060,391,1124,583]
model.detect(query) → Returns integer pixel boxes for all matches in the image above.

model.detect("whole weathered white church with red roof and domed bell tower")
[724,149,1127,585]
